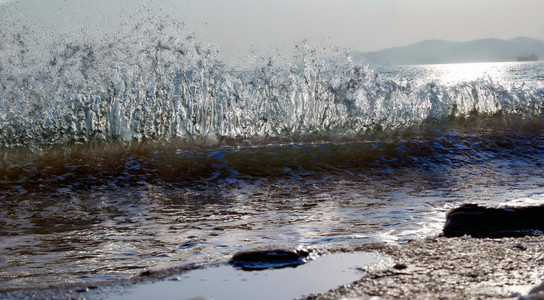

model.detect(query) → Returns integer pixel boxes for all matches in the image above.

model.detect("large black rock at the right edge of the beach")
[443,204,544,238]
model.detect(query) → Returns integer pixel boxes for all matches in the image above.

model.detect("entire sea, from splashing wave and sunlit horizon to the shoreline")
[0,4,544,291]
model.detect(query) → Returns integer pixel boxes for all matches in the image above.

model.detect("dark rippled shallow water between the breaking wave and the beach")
[0,133,544,288]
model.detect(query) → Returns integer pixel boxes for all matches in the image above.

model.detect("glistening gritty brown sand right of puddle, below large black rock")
[307,236,544,299]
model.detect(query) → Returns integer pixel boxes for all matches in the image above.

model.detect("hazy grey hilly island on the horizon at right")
[351,37,544,65]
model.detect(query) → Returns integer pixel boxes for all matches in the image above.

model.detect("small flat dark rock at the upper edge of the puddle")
[229,249,313,271]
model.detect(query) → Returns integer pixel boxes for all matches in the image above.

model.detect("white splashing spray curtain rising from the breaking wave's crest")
[0,7,544,149]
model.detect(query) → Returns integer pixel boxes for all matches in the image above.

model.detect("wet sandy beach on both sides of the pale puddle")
[3,236,544,299]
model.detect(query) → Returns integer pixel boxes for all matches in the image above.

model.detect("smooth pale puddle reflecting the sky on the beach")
[101,252,386,300]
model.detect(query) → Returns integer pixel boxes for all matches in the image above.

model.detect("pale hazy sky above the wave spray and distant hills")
[0,0,544,61]
